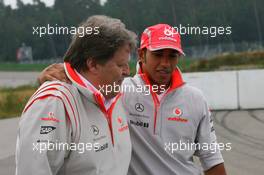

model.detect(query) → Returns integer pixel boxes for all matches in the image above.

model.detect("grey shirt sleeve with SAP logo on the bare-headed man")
[16,96,71,175]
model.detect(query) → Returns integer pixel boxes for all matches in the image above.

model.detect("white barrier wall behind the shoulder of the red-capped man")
[183,70,264,110]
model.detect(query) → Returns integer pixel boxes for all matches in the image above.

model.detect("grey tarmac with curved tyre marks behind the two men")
[0,110,264,175]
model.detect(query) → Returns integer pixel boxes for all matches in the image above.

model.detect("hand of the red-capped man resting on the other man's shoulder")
[38,63,71,85]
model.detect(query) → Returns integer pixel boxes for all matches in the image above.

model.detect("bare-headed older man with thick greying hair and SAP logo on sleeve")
[16,16,136,175]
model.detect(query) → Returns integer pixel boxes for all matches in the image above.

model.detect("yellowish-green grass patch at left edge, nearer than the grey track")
[0,86,37,119]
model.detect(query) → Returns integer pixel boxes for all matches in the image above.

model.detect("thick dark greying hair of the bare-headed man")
[64,15,137,72]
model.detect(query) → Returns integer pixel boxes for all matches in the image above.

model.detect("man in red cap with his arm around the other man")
[39,24,226,175]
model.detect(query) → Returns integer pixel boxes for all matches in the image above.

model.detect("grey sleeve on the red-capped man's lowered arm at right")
[195,102,224,171]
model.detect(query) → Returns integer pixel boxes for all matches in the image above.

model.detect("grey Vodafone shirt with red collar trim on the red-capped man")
[123,72,223,175]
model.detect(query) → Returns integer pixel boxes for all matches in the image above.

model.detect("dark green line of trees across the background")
[0,0,264,62]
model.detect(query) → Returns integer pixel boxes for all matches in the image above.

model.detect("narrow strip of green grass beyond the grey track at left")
[0,63,49,71]
